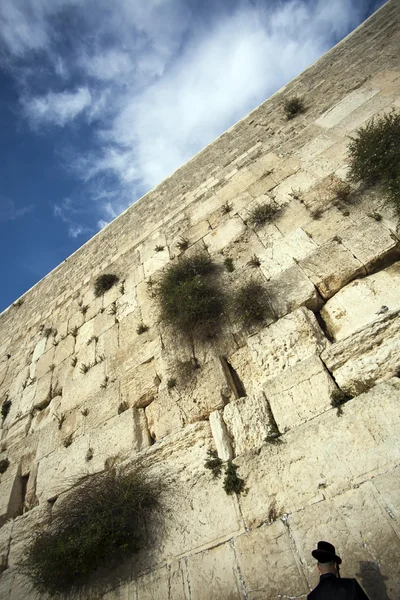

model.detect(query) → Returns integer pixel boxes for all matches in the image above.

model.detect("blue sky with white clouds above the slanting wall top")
[0,0,384,311]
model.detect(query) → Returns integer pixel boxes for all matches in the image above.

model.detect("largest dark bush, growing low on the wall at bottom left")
[21,466,161,595]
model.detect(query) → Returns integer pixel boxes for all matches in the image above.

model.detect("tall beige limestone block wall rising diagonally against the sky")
[0,0,400,600]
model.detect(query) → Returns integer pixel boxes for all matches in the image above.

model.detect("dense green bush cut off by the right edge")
[348,111,400,213]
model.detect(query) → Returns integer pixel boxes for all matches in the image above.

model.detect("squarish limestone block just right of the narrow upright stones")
[264,356,337,433]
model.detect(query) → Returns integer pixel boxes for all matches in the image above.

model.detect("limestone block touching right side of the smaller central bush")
[266,265,322,318]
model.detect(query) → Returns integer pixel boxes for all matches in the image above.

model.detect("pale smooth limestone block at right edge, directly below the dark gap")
[321,263,400,341]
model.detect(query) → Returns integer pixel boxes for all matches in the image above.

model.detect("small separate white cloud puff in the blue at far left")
[22,87,92,127]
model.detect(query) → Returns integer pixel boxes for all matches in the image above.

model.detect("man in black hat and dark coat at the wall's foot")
[307,542,368,600]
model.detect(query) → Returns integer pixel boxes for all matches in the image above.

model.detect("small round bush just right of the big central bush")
[232,280,271,327]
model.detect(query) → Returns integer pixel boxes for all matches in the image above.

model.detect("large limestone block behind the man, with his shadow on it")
[288,482,400,600]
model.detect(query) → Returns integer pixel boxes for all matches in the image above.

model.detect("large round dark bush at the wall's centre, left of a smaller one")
[156,253,225,340]
